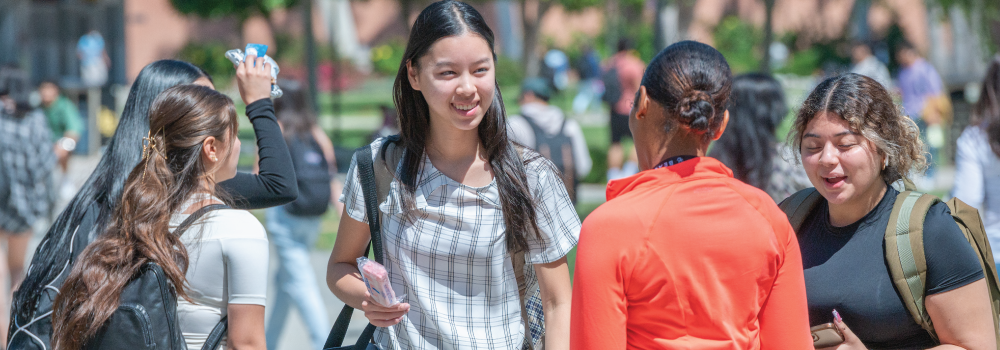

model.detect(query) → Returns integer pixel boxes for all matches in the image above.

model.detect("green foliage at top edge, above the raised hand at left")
[170,0,299,21]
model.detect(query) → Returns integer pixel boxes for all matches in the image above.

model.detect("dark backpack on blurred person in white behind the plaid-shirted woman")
[523,116,580,204]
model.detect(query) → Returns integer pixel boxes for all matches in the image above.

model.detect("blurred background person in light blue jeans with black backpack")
[265,81,343,350]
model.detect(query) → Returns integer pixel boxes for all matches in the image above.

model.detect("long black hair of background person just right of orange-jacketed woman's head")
[709,73,788,191]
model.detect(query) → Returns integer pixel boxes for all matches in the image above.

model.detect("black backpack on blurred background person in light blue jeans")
[285,134,333,216]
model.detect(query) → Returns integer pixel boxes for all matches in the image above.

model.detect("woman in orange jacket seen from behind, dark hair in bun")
[571,41,812,350]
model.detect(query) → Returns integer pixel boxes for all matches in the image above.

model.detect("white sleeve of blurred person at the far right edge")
[951,127,992,211]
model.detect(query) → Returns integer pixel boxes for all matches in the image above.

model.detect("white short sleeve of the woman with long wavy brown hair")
[219,211,268,305]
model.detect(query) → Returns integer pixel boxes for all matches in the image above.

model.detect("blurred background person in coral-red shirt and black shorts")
[601,39,646,181]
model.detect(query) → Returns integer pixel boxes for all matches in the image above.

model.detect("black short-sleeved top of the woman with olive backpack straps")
[799,187,983,349]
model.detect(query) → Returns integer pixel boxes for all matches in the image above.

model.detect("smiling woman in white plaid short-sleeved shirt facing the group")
[327,0,579,350]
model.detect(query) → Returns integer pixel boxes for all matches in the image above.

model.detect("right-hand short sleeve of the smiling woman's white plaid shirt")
[525,158,580,264]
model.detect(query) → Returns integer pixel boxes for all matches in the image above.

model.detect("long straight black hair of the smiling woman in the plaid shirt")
[394,0,538,251]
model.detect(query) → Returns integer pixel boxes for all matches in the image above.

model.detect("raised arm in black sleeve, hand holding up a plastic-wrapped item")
[219,57,299,209]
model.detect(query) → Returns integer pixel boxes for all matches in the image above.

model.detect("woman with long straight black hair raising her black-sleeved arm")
[7,58,297,349]
